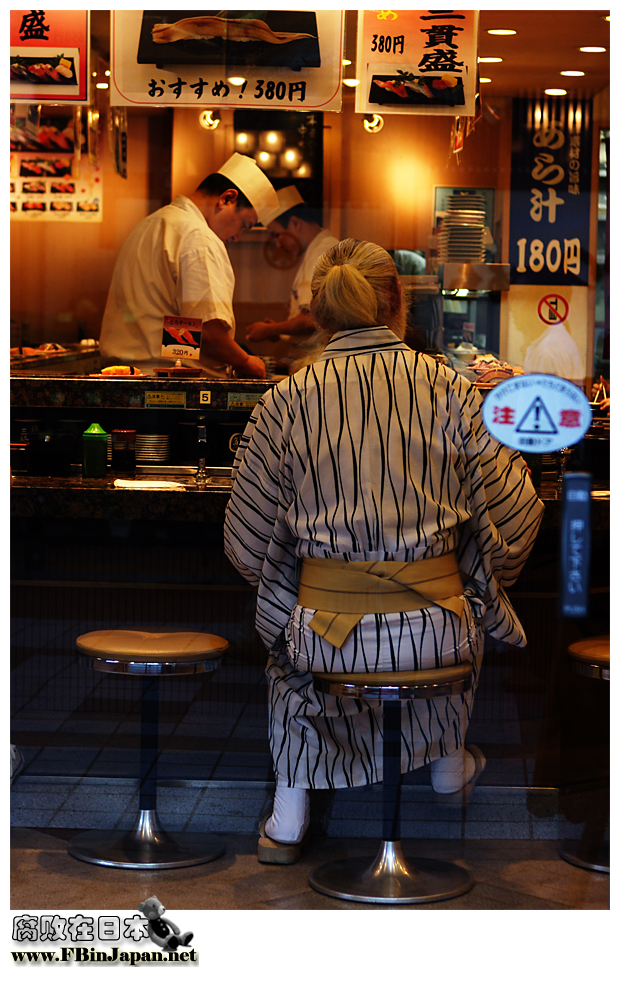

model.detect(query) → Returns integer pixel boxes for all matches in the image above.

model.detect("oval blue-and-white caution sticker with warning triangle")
[482,375,592,454]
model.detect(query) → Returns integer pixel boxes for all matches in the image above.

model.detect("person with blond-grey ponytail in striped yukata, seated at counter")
[225,239,543,862]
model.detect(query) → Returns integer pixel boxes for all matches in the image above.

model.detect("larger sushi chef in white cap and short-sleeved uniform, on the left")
[99,153,278,378]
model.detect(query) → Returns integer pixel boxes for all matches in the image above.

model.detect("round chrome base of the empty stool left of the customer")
[69,811,225,870]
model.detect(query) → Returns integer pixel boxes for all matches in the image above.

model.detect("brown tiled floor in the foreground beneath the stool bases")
[10,828,609,914]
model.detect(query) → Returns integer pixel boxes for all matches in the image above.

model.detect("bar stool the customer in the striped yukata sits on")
[308,663,474,904]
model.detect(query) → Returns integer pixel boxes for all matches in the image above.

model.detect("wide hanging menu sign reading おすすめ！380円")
[110,10,344,110]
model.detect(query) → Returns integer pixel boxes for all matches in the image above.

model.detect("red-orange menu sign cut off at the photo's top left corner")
[10,8,90,104]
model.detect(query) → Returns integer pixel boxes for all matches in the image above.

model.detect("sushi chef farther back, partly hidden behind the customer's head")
[247,186,338,342]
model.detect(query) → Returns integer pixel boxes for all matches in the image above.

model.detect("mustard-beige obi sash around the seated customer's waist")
[297,551,465,648]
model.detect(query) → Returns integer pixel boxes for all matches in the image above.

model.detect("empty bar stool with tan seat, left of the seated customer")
[69,629,229,870]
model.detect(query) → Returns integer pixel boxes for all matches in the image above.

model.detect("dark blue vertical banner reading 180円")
[510,98,592,286]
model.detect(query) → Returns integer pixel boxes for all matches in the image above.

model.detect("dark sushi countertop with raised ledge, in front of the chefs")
[11,374,609,529]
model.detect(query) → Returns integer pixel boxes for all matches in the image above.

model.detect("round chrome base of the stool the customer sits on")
[308,840,474,904]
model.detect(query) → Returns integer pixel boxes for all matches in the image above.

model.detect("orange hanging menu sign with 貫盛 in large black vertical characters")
[355,10,478,117]
